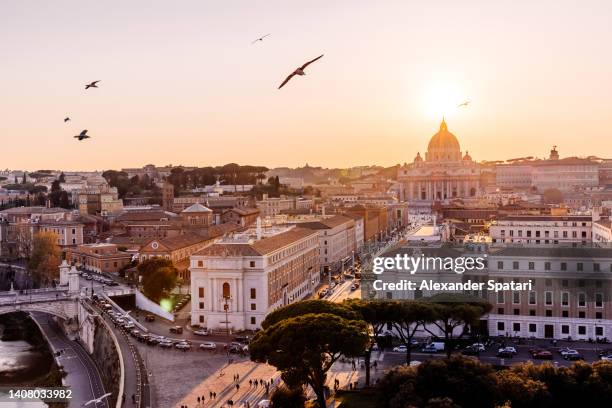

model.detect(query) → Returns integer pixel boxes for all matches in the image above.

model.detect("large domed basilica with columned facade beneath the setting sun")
[398,119,481,203]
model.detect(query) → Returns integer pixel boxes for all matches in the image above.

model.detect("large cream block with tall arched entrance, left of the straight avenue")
[190,228,319,332]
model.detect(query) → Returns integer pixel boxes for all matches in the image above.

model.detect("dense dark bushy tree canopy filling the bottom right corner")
[377,356,612,408]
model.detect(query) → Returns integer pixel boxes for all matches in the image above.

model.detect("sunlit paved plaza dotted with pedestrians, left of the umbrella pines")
[175,361,280,408]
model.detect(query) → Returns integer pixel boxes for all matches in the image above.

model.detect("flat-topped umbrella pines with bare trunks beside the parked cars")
[250,296,491,408]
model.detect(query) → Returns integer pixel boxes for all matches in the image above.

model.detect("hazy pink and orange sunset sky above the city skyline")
[0,0,612,170]
